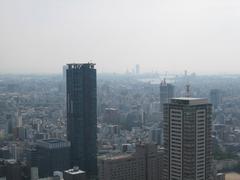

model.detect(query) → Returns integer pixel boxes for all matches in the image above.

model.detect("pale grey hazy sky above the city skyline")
[0,0,240,73]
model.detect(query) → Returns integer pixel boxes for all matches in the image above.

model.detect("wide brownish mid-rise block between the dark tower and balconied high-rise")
[98,144,163,180]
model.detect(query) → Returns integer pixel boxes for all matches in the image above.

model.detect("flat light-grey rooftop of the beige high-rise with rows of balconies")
[171,97,209,105]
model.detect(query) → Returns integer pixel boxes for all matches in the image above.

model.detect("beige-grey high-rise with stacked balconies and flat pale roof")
[163,97,212,180]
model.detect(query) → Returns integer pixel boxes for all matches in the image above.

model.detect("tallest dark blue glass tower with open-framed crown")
[67,63,97,179]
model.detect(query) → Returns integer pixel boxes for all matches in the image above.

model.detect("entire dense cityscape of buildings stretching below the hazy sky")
[0,63,240,180]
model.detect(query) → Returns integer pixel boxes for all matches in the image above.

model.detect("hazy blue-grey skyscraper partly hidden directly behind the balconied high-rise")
[160,79,174,118]
